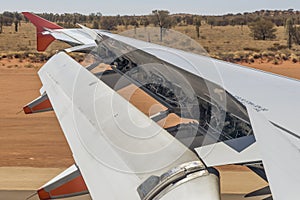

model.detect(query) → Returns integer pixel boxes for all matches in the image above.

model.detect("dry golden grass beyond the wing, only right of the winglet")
[116,25,300,63]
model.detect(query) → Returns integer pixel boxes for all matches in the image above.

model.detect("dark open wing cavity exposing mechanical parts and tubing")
[89,39,253,149]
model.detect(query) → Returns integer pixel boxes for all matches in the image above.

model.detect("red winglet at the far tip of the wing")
[22,12,62,51]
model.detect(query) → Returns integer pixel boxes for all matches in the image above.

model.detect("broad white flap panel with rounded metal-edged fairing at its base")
[34,53,219,199]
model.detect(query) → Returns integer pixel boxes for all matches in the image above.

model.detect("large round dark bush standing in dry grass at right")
[249,18,276,40]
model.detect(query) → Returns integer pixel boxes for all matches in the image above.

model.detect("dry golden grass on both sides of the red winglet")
[0,22,300,63]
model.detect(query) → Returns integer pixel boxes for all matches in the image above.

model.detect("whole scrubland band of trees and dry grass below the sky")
[0,9,300,64]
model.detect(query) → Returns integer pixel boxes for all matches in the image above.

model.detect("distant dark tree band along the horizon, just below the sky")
[0,9,300,29]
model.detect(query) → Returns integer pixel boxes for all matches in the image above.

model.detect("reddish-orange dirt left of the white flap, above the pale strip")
[0,61,73,167]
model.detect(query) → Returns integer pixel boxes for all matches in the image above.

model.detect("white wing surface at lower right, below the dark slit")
[248,108,300,199]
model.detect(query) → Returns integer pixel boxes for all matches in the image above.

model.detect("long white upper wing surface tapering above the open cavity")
[101,32,300,136]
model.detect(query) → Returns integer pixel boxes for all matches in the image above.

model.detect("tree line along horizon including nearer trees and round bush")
[0,9,300,48]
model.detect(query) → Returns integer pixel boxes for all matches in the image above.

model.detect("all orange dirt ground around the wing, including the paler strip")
[0,59,300,194]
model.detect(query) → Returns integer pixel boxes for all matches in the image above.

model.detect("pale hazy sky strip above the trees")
[0,0,300,15]
